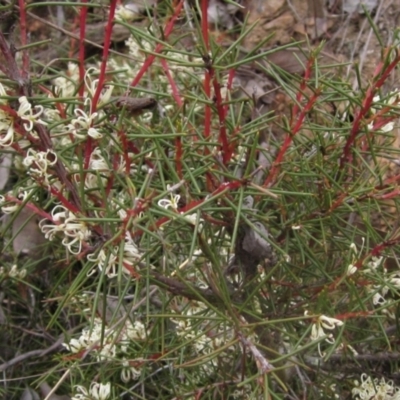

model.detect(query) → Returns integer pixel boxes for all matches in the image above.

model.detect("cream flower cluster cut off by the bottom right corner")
[351,374,400,400]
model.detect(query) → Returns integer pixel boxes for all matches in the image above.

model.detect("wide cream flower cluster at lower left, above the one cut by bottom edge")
[63,319,148,382]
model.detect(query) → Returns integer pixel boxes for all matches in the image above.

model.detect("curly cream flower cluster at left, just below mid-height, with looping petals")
[39,205,91,254]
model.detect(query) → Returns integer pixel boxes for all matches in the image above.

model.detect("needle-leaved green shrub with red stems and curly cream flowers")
[0,0,400,399]
